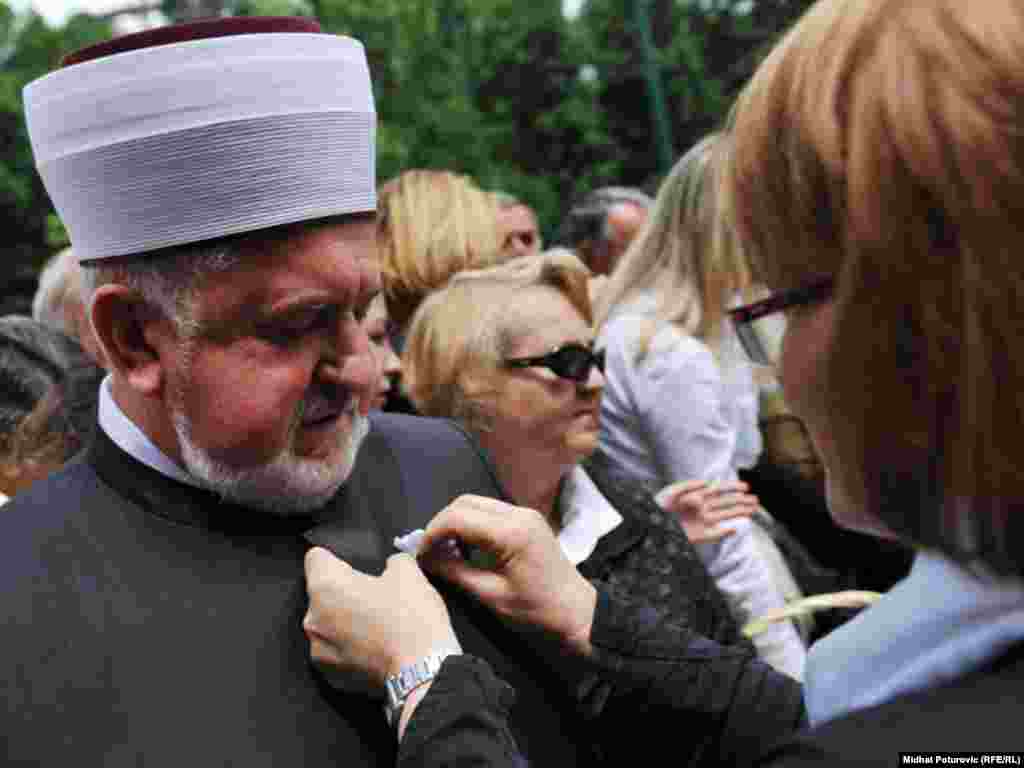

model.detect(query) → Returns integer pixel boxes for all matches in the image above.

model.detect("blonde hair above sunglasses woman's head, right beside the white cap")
[378,170,504,327]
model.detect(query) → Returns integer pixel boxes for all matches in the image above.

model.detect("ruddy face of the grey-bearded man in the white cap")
[167,220,380,513]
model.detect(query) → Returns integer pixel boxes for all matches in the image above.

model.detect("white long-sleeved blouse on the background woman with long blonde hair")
[596,296,806,679]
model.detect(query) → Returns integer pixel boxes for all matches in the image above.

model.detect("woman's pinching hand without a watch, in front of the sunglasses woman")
[420,496,597,655]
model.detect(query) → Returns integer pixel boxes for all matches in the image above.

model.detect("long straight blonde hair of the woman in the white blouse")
[596,134,750,358]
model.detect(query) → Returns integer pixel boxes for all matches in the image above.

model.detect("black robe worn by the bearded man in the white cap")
[0,415,590,768]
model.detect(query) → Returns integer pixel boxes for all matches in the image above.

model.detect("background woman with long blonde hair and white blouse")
[595,135,806,679]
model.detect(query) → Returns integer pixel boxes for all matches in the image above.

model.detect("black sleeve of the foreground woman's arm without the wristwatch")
[574,588,805,766]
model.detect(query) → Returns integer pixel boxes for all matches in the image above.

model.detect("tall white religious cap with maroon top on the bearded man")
[25,16,377,261]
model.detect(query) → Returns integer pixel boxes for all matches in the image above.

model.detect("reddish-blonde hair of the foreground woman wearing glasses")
[726,0,1024,574]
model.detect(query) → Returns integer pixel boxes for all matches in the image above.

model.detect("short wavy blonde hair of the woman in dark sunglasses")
[401,249,593,431]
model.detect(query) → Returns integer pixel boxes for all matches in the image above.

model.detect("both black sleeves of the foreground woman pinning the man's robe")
[398,590,805,768]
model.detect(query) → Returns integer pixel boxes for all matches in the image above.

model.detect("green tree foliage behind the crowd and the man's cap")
[0,0,811,274]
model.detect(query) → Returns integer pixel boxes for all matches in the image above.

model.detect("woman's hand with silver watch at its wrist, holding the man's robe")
[302,547,459,696]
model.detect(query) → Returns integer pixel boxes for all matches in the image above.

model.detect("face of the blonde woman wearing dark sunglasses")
[480,289,604,472]
